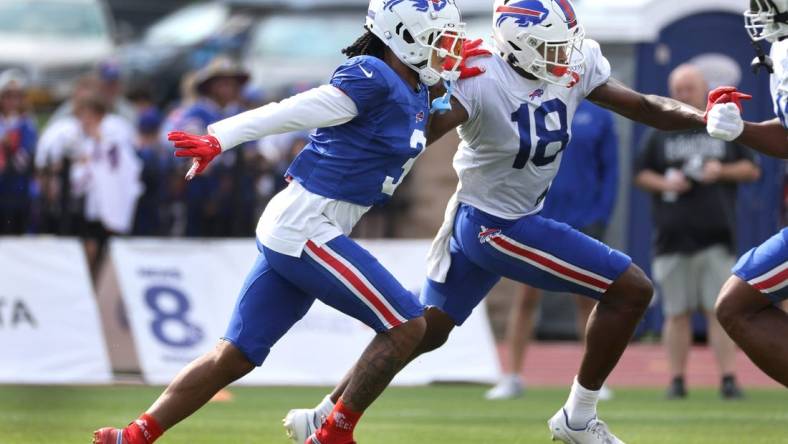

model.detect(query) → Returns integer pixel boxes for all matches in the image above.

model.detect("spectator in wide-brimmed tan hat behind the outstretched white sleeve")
[163,56,256,236]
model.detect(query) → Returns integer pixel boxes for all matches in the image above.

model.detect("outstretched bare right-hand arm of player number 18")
[588,78,706,131]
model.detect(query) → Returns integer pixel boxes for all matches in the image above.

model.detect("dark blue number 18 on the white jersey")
[512,99,569,170]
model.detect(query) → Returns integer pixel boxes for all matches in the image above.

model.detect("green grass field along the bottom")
[0,386,788,444]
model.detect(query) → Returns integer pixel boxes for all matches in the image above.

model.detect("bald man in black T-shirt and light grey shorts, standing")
[635,64,760,399]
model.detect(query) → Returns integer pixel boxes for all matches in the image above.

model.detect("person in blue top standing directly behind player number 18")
[485,100,618,399]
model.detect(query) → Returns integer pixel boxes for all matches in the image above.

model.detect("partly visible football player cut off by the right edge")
[706,0,788,387]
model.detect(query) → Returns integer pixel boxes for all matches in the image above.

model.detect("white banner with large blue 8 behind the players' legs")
[111,239,499,385]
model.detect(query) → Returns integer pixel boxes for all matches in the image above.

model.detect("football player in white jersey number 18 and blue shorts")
[285,0,720,444]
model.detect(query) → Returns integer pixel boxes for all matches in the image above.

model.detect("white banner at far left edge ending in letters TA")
[0,237,112,384]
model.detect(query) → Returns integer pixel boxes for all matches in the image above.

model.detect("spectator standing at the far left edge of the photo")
[0,69,37,235]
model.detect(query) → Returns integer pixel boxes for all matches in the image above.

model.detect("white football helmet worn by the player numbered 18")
[493,0,585,86]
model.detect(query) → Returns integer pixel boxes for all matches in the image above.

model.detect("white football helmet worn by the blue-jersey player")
[366,0,465,86]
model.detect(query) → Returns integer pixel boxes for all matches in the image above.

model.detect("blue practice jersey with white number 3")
[287,56,429,206]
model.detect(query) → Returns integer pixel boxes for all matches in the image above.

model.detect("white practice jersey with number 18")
[454,39,610,219]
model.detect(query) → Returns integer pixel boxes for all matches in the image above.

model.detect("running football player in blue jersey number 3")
[93,0,464,444]
